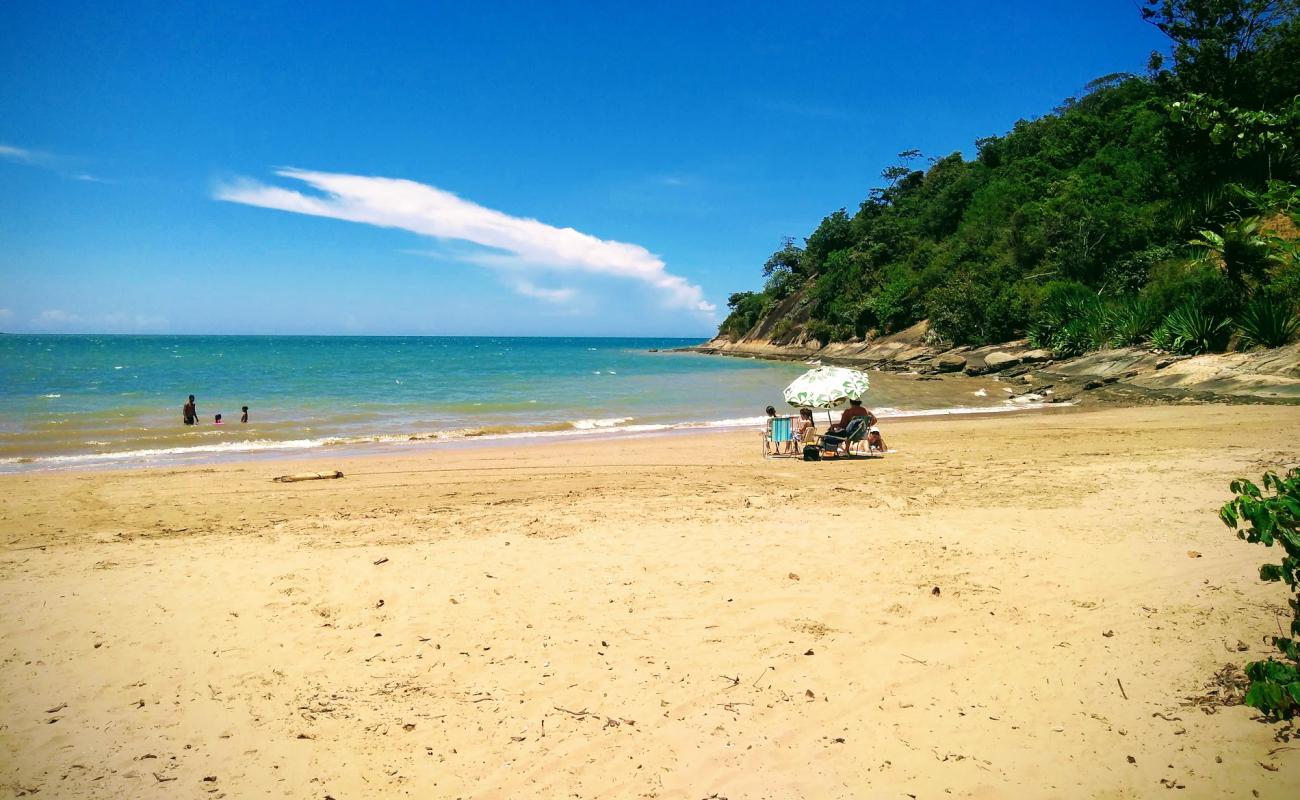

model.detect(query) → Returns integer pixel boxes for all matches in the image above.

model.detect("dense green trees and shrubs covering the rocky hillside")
[719,0,1300,354]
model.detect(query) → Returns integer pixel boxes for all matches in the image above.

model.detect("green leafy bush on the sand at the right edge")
[1219,468,1300,719]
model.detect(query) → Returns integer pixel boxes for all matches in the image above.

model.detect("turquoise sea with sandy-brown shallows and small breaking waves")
[0,334,1034,471]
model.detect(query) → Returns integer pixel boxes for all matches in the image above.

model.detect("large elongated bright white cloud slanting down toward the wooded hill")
[216,169,715,312]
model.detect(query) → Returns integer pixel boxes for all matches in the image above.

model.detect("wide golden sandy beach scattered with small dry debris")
[0,406,1300,800]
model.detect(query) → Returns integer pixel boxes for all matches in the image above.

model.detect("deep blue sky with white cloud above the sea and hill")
[0,0,1166,336]
